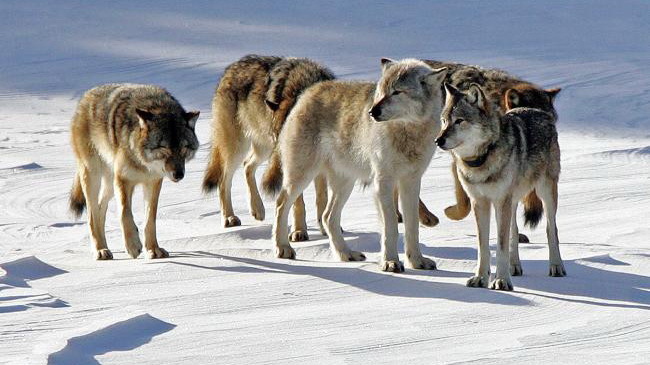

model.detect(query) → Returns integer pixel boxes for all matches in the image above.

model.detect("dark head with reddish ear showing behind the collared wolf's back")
[503,83,562,119]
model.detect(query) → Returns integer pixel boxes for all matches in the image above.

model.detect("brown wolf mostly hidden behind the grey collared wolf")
[410,60,561,242]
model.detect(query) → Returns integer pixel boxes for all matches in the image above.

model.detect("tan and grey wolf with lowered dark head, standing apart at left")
[70,84,199,260]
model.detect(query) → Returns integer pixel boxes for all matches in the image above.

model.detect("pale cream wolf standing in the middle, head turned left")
[266,59,445,272]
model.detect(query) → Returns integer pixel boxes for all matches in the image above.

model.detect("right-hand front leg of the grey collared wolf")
[490,197,516,291]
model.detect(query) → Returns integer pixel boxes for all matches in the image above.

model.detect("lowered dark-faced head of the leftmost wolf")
[135,109,199,182]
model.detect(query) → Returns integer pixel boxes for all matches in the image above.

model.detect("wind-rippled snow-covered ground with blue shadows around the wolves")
[0,0,650,365]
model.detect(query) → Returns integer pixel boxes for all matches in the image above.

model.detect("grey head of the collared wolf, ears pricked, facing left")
[436,83,500,157]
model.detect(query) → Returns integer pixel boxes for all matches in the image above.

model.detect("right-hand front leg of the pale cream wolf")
[398,177,436,270]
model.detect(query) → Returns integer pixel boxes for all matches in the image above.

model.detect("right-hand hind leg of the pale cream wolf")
[323,173,366,261]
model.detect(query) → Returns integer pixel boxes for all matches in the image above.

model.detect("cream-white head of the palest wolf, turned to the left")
[368,58,446,122]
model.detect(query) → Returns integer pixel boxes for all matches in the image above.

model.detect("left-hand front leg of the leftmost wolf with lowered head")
[113,173,142,258]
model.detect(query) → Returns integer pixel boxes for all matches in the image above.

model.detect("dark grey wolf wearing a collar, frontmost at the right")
[436,83,566,290]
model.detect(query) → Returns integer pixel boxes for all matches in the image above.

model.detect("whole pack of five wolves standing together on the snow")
[70,55,566,290]
